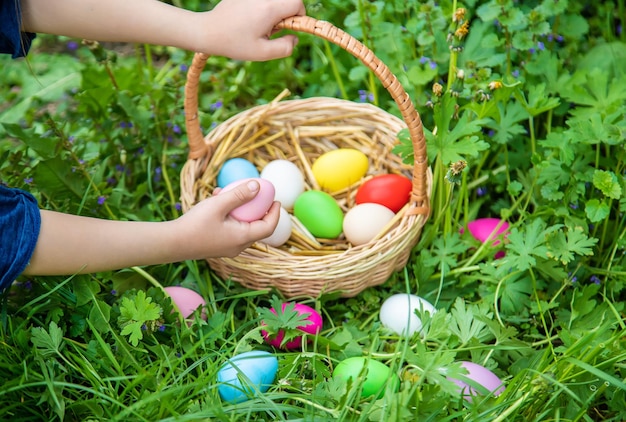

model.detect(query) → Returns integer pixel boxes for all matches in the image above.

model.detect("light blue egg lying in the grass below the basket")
[217,350,278,403]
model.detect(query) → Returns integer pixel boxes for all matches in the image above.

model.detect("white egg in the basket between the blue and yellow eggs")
[261,160,304,210]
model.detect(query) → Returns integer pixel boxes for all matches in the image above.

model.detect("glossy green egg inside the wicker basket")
[293,190,343,239]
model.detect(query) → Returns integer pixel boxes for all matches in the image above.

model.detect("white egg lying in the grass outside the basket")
[380,293,437,336]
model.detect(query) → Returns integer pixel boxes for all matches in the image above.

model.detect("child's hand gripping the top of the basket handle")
[194,0,306,61]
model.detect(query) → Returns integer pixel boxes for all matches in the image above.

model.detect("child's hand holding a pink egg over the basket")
[174,182,280,259]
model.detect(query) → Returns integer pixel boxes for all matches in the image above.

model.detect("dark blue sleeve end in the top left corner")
[0,0,35,59]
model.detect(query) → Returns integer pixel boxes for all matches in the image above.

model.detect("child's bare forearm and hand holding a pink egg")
[24,180,280,275]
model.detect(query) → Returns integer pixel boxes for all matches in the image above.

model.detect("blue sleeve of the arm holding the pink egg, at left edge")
[0,185,41,291]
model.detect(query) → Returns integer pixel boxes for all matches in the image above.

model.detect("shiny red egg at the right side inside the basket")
[355,174,412,213]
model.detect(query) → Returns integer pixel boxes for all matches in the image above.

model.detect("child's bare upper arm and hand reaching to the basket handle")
[22,0,305,60]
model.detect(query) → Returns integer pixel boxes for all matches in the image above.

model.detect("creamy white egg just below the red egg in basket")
[343,202,395,246]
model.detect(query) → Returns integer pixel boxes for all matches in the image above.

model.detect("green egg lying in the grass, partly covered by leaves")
[333,357,400,398]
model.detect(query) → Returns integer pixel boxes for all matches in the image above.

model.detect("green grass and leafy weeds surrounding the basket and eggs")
[0,0,626,421]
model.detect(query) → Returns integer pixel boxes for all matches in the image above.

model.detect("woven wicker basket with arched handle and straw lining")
[181,17,431,298]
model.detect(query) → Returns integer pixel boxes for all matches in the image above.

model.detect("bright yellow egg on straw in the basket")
[311,148,369,192]
